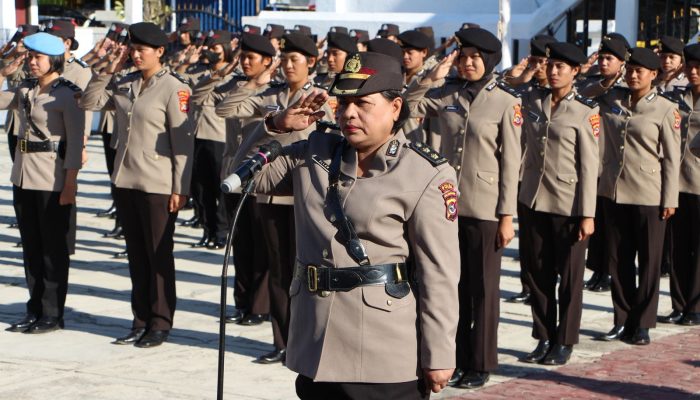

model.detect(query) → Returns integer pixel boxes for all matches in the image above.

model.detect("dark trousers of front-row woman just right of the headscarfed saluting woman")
[520,206,588,345]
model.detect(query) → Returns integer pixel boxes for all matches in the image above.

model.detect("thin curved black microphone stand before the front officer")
[216,179,255,400]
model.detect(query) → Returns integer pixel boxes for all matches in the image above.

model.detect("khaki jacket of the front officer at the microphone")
[255,133,460,383]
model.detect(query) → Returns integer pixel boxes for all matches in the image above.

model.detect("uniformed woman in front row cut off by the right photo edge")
[658,43,700,325]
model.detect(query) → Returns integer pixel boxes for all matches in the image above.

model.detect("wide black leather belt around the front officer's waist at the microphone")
[294,261,408,292]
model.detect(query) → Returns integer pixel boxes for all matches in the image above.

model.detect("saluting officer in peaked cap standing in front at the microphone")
[256,52,459,399]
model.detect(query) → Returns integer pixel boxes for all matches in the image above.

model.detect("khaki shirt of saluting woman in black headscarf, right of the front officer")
[404,79,523,221]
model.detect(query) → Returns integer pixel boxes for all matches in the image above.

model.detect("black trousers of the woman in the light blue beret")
[12,186,75,318]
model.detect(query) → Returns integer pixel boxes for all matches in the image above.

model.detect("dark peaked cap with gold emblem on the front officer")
[329,51,403,96]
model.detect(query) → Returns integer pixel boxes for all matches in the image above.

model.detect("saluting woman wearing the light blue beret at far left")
[0,32,85,333]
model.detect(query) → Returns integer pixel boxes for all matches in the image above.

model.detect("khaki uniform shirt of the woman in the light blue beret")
[0,78,85,192]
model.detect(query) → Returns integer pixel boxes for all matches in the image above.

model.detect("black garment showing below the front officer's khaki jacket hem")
[295,375,430,400]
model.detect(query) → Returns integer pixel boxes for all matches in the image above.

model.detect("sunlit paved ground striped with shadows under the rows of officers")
[0,132,700,400]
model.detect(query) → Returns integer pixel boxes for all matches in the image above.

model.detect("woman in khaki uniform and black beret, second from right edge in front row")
[598,48,681,345]
